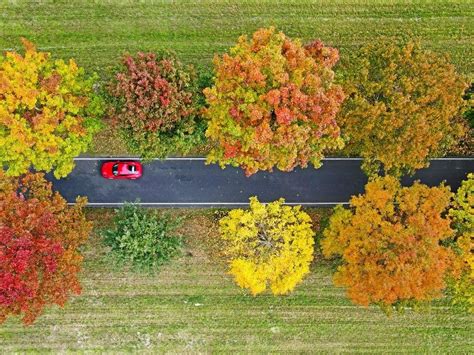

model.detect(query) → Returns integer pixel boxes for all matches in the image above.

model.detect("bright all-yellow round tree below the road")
[219,197,314,295]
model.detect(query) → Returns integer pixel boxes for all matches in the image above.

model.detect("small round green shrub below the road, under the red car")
[101,203,183,269]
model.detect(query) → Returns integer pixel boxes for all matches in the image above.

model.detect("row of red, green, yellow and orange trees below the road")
[0,172,474,325]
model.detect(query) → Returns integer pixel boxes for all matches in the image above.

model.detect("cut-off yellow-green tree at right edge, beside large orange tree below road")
[449,173,474,312]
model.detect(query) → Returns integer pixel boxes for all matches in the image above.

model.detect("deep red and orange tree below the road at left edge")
[0,171,92,324]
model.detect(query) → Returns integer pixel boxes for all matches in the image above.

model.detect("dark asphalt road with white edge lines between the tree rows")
[47,158,474,207]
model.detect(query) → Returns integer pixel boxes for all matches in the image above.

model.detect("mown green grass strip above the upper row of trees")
[0,0,474,74]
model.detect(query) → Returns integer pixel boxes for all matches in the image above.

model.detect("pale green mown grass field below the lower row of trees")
[0,210,474,353]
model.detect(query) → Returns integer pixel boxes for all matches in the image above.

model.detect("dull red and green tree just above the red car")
[110,53,204,159]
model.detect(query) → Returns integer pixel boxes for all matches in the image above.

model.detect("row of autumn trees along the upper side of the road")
[0,27,472,177]
